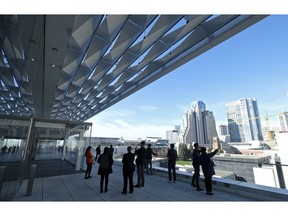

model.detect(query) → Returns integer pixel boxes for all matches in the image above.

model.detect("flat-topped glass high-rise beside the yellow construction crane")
[226,98,263,142]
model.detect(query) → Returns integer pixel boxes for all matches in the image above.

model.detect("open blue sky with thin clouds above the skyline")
[89,15,288,139]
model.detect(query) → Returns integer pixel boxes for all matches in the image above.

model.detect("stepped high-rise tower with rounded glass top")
[180,101,217,145]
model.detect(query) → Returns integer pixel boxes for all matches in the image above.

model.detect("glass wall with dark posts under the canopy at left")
[0,117,92,200]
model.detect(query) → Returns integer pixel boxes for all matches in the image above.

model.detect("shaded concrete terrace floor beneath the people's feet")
[13,163,257,202]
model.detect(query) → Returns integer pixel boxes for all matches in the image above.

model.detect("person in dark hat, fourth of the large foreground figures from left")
[134,141,147,188]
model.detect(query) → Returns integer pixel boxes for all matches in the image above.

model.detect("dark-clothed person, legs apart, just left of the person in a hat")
[122,146,135,194]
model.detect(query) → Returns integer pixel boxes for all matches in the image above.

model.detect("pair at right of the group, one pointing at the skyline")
[191,143,218,195]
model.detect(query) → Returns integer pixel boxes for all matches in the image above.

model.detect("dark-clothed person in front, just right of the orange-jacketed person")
[98,147,114,193]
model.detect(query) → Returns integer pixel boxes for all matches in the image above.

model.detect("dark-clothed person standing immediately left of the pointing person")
[191,143,203,191]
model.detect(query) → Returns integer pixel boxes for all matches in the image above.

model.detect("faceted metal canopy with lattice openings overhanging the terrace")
[0,15,266,121]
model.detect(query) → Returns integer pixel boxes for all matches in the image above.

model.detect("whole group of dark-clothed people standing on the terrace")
[84,141,218,195]
